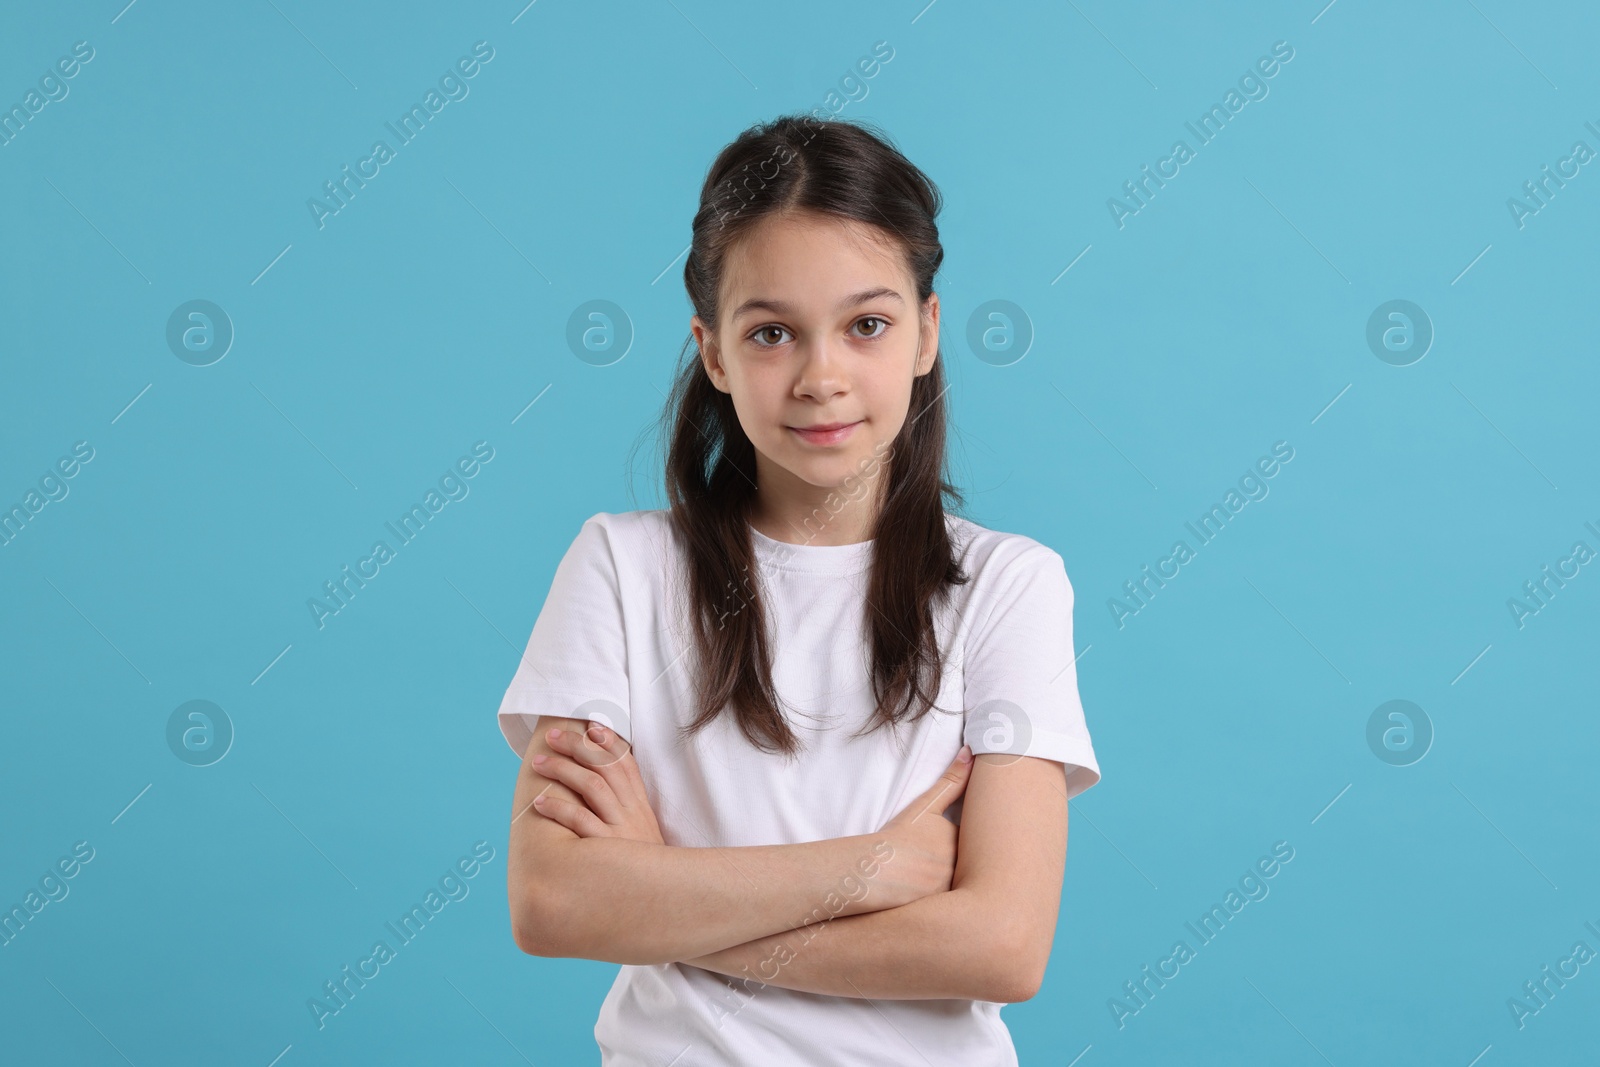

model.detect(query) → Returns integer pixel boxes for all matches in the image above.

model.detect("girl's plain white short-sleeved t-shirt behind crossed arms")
[498,510,1099,1067]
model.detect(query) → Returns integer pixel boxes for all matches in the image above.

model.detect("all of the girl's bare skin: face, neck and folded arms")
[510,206,1067,1001]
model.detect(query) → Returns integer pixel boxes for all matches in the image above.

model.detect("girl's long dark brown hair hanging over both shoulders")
[661,115,968,755]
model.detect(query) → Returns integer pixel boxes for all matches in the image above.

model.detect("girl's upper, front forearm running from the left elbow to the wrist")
[507,755,904,963]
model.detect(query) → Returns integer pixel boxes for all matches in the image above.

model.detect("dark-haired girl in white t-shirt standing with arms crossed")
[499,117,1099,1067]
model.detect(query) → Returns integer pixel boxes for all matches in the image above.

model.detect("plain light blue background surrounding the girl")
[0,0,1600,1067]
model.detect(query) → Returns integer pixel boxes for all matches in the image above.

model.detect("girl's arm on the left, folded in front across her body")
[507,715,971,965]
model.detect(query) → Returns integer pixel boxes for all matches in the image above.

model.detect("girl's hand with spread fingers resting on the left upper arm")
[530,723,666,845]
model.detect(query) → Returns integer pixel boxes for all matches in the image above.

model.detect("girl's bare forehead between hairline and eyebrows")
[722,213,915,310]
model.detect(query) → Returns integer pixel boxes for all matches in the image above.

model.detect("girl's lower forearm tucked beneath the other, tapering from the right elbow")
[682,888,1027,1003]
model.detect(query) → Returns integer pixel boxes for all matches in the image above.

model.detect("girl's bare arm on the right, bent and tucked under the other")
[680,753,1067,1003]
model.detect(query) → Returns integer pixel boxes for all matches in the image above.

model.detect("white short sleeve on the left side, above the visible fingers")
[498,512,634,758]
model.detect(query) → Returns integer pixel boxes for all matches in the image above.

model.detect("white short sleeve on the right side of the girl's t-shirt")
[963,544,1101,800]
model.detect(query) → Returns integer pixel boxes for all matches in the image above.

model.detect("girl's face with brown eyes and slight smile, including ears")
[691,213,939,504]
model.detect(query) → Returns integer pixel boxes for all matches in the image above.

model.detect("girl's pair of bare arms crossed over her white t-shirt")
[507,717,1067,1001]
